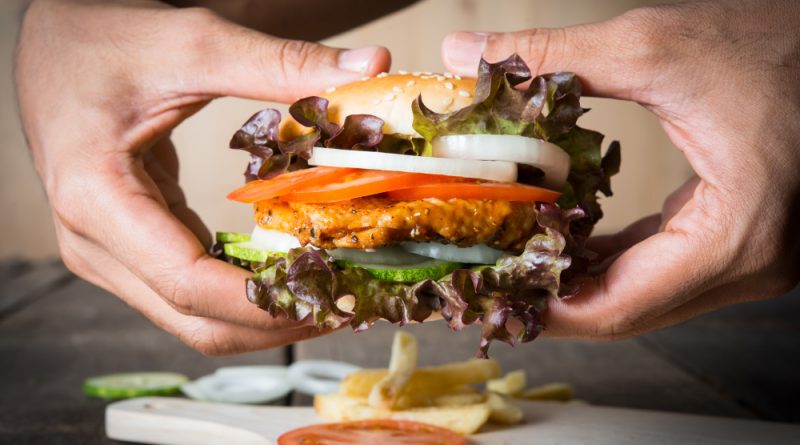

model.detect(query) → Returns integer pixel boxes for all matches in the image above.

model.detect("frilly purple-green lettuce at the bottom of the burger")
[234,204,584,357]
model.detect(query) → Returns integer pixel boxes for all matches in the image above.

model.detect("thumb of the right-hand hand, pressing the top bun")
[442,14,655,102]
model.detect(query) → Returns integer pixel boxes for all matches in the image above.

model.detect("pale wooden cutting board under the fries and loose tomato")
[106,397,800,445]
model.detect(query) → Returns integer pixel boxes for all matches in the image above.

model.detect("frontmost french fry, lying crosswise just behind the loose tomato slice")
[314,394,490,434]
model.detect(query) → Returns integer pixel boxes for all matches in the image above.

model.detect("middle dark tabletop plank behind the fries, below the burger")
[295,322,753,417]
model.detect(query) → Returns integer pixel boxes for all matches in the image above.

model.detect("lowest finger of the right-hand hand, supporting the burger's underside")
[545,225,721,337]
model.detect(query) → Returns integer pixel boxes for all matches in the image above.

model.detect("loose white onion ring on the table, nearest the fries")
[289,360,361,396]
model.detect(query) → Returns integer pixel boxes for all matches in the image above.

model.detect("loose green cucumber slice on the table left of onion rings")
[83,372,189,399]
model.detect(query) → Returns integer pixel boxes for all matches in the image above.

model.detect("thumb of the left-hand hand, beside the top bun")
[185,15,391,103]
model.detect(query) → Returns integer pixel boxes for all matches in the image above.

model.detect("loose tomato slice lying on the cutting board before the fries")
[278,419,467,445]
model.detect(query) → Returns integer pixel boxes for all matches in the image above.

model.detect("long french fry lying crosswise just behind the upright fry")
[339,359,500,398]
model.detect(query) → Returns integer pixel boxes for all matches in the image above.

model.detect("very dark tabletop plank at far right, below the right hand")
[642,288,800,422]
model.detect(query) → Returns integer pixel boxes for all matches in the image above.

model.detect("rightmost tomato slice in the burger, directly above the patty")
[387,182,561,202]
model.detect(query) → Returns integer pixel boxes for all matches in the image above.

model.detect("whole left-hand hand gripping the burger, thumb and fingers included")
[15,1,390,354]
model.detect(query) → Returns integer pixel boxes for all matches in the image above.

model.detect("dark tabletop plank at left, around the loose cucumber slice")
[0,280,284,444]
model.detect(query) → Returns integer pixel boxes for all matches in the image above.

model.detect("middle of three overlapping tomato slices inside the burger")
[281,170,464,203]
